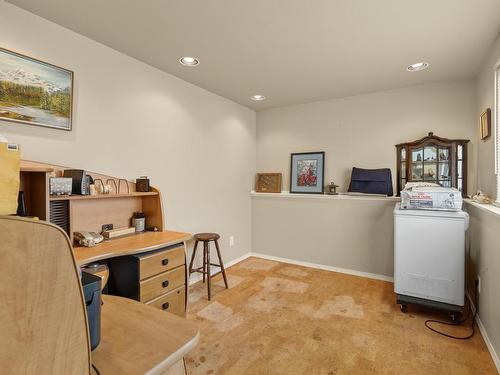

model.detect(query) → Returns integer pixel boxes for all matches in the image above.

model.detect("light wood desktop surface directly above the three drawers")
[73,231,192,266]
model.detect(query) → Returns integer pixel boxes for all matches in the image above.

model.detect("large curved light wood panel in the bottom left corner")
[0,216,91,375]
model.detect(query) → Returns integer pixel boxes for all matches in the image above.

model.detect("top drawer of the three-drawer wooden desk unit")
[137,246,185,280]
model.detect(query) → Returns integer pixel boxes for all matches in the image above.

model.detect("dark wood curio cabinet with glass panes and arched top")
[396,133,469,197]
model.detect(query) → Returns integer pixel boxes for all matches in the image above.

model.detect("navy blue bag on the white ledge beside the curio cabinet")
[348,167,393,196]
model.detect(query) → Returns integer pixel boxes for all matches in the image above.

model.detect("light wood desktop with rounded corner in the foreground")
[91,295,199,375]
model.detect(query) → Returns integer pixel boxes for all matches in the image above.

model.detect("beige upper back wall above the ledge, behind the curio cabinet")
[257,79,477,195]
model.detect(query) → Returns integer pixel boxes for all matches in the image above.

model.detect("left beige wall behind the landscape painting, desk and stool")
[0,2,255,261]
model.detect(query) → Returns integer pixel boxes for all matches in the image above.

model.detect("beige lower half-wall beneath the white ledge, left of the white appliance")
[252,195,396,277]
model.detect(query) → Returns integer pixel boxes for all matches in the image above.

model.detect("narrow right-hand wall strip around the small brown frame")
[475,32,500,197]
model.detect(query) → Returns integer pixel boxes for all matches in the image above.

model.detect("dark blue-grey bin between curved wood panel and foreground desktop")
[82,271,101,350]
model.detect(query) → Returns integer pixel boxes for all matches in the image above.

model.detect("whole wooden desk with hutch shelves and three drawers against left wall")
[20,161,191,316]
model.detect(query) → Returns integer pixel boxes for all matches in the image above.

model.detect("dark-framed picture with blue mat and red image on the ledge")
[290,151,325,194]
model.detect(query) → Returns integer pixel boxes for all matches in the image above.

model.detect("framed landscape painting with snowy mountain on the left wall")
[0,48,73,130]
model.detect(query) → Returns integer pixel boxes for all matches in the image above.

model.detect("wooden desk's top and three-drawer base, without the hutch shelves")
[73,231,192,316]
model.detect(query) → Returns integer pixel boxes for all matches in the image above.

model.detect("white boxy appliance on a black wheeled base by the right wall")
[394,203,469,316]
